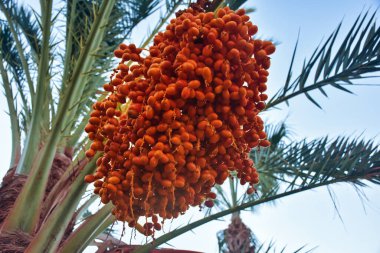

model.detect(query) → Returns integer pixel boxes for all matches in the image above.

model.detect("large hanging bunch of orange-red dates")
[85,1,275,235]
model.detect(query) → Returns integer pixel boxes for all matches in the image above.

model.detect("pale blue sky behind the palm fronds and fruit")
[0,0,380,253]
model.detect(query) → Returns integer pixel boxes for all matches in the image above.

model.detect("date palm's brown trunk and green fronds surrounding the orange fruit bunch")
[0,0,380,252]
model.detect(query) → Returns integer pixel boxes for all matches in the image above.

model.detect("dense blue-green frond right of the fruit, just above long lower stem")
[258,137,380,189]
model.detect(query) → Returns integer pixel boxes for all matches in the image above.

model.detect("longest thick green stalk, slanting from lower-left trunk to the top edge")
[4,0,115,235]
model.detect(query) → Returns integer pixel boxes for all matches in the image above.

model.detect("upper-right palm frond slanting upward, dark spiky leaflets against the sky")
[267,11,380,109]
